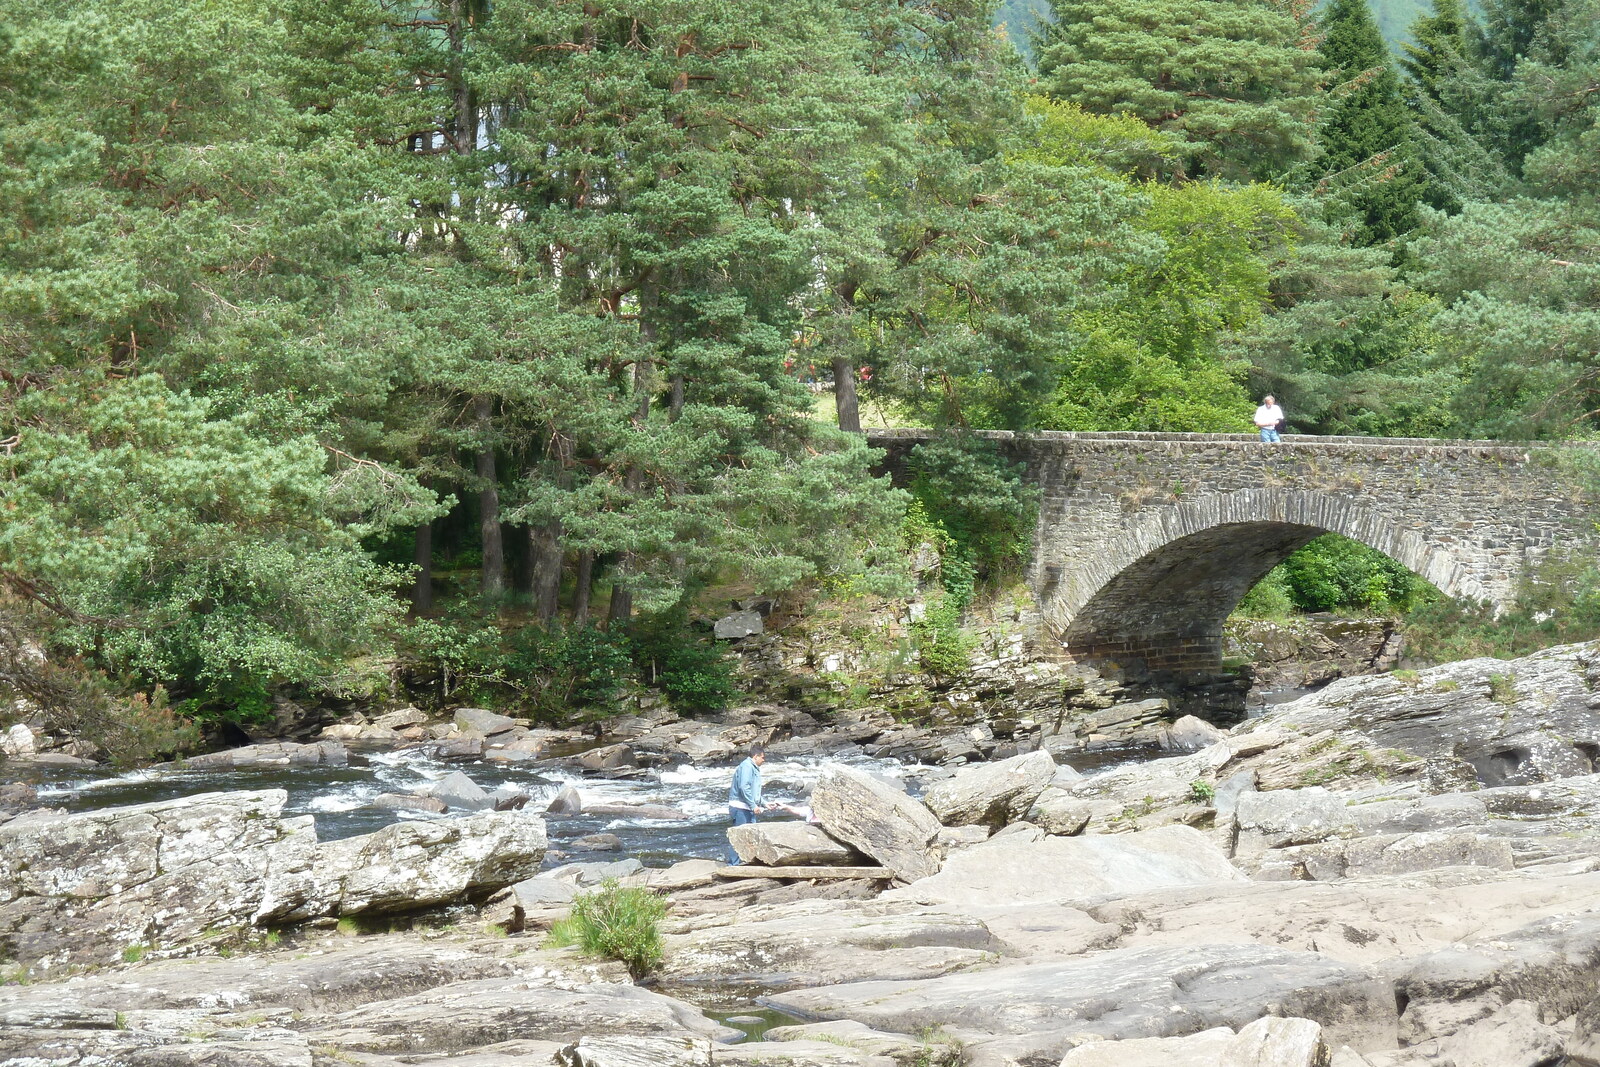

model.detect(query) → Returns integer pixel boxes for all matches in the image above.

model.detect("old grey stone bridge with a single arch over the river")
[869,430,1594,673]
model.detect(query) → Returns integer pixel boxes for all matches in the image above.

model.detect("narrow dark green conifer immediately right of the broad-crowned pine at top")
[1312,0,1426,245]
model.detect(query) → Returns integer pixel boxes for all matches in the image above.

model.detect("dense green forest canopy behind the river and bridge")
[0,0,1600,735]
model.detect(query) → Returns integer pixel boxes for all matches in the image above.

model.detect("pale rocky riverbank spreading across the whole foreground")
[0,646,1600,1067]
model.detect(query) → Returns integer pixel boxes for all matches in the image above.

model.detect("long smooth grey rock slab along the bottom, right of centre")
[768,945,1397,1059]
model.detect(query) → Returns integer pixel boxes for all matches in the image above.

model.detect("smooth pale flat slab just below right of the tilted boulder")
[885,825,1246,905]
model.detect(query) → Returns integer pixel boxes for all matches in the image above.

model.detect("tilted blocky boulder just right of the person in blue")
[811,766,939,881]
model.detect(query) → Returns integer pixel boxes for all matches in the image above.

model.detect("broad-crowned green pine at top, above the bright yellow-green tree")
[1038,0,1318,179]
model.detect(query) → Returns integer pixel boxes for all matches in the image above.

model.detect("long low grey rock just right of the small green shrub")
[661,901,1005,989]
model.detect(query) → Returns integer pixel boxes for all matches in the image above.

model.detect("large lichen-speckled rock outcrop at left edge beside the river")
[0,789,315,971]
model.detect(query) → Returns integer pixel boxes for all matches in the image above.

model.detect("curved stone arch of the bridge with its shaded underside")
[1045,488,1494,670]
